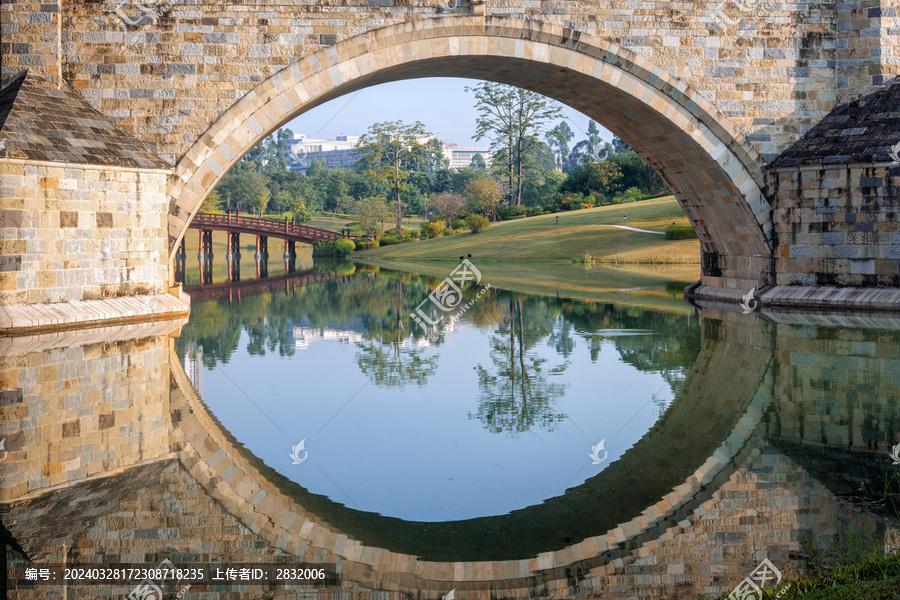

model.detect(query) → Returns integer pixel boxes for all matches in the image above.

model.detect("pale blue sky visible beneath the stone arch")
[287,77,612,146]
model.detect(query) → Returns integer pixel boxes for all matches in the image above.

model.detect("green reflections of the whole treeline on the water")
[176,265,700,414]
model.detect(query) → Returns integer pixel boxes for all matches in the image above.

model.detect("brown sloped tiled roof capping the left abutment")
[0,71,171,169]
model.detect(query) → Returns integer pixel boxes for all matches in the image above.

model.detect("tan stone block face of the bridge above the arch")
[0,0,844,164]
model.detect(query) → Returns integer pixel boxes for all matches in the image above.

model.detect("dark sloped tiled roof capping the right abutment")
[772,81,900,167]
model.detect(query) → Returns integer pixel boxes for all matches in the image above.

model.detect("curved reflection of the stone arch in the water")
[171,316,771,598]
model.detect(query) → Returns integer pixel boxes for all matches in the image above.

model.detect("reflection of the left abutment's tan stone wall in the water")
[0,322,177,505]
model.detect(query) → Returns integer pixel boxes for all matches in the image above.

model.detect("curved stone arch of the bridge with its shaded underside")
[168,16,773,288]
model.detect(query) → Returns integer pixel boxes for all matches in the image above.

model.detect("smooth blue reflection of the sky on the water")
[203,318,672,521]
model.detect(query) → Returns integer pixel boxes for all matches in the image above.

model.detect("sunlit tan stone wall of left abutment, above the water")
[0,159,168,306]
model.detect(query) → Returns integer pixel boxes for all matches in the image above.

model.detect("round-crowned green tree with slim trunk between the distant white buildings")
[356,121,431,235]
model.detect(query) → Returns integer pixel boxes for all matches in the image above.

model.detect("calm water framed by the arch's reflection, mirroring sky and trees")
[172,270,700,521]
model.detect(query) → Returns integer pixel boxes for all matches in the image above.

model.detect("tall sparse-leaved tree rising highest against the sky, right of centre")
[466,82,562,205]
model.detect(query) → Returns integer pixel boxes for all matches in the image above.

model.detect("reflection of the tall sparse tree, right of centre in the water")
[469,297,568,433]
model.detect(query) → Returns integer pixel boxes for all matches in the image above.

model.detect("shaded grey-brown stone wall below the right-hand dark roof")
[773,165,900,287]
